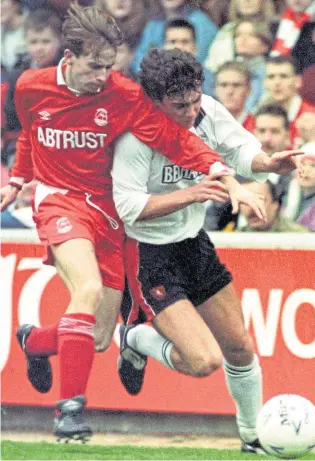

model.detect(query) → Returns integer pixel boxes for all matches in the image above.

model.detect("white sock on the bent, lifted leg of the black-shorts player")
[127,325,174,370]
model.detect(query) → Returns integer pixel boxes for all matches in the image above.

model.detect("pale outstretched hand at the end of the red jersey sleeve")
[221,176,267,221]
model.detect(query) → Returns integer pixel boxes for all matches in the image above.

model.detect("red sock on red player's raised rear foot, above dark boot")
[26,322,59,355]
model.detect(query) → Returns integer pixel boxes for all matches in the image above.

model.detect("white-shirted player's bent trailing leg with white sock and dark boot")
[118,300,222,395]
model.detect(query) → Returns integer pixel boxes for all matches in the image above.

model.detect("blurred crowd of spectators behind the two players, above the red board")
[1,0,315,232]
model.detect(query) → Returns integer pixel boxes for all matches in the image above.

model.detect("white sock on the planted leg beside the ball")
[223,355,263,442]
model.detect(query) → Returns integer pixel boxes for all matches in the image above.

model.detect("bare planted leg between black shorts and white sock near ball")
[197,283,253,363]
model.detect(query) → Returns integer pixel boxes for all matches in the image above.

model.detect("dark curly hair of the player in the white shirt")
[139,48,204,102]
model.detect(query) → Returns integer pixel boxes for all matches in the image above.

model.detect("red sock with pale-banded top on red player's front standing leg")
[58,313,96,399]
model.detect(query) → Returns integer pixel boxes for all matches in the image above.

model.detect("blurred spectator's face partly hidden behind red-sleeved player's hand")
[240,182,279,231]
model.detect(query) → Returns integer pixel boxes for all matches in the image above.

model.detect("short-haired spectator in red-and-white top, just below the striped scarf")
[264,56,315,148]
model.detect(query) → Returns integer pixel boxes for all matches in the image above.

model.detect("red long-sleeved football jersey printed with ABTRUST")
[11,63,225,195]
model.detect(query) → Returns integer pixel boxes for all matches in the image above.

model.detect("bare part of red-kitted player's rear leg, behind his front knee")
[94,286,122,351]
